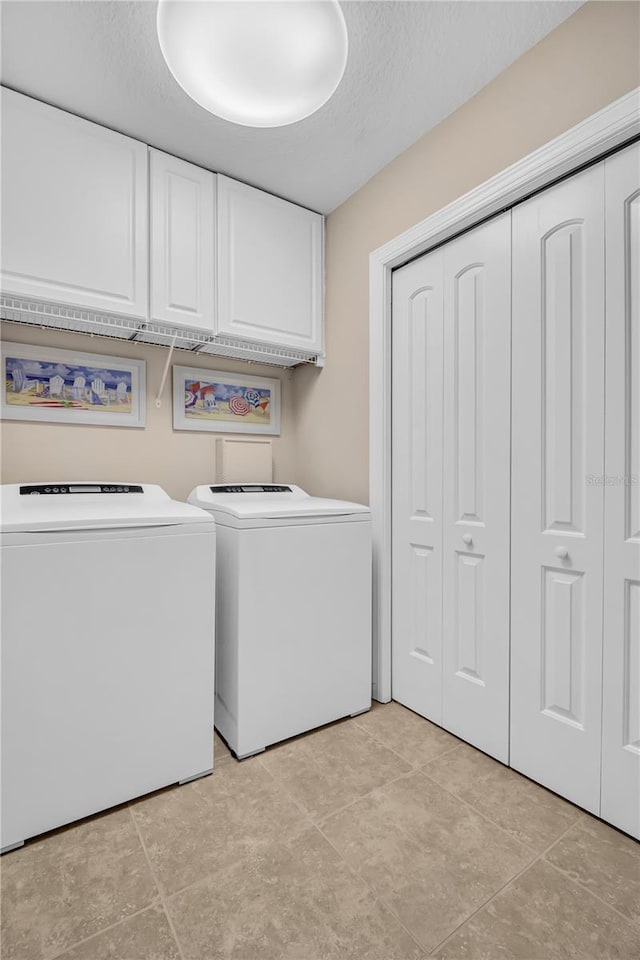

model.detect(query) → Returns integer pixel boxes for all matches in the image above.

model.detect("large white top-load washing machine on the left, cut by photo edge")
[0,483,215,851]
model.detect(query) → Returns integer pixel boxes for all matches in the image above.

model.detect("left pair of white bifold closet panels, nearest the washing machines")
[392,214,511,761]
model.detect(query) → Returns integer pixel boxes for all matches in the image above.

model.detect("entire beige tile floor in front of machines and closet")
[0,703,640,960]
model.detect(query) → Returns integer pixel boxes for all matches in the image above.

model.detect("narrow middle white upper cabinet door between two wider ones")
[150,150,215,334]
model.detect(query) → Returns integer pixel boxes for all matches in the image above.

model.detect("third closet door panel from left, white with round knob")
[511,164,604,813]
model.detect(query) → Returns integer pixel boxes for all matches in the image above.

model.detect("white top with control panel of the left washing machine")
[0,481,211,533]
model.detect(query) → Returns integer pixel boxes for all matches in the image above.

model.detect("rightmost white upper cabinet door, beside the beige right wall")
[217,176,323,353]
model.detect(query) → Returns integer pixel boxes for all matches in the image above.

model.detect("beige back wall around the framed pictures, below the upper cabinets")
[1,322,295,500]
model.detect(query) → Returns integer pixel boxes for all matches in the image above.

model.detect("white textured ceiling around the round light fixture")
[0,0,581,213]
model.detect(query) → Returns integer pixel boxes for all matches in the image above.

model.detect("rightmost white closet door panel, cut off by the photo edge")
[601,145,640,838]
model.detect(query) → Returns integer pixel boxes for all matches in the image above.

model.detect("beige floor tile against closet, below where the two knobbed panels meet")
[425,744,581,853]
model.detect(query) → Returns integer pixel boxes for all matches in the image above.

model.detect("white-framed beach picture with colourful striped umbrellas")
[173,367,280,435]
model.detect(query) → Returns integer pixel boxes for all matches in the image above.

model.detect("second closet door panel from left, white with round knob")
[442,213,511,763]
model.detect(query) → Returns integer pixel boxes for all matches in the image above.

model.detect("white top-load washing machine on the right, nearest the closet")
[189,483,371,759]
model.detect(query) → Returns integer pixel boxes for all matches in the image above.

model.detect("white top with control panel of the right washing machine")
[188,483,370,520]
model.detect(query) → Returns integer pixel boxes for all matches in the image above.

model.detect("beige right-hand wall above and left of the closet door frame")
[294,2,640,502]
